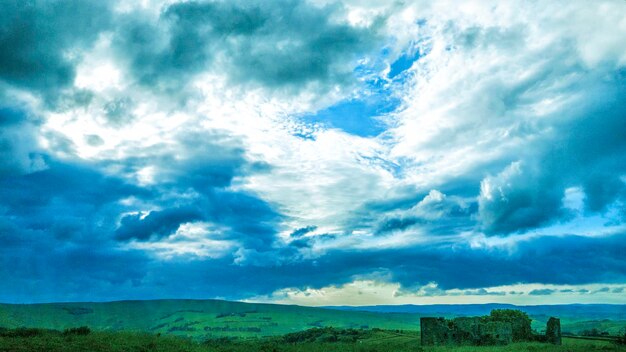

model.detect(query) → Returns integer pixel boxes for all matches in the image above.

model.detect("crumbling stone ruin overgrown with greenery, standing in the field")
[420,311,561,346]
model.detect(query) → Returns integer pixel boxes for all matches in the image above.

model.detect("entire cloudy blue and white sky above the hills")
[0,0,626,305]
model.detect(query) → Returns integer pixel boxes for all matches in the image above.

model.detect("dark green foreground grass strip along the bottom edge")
[0,330,626,352]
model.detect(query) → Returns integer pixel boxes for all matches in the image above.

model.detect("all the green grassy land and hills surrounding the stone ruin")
[0,300,626,352]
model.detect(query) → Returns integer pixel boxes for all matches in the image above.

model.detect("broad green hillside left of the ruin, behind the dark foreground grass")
[0,300,419,339]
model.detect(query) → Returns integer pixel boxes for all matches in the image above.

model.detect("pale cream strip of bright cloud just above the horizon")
[250,279,626,306]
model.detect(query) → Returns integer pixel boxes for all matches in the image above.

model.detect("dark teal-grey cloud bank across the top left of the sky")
[0,0,380,102]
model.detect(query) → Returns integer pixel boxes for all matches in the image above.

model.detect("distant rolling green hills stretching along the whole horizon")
[0,300,626,339]
